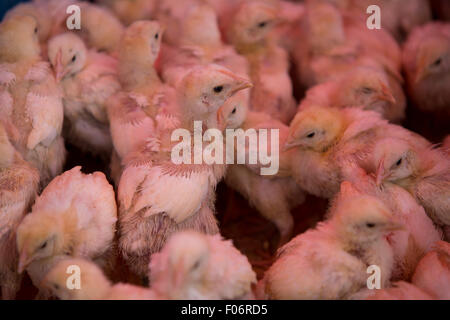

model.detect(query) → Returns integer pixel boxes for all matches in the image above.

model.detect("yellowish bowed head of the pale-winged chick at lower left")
[16,214,64,272]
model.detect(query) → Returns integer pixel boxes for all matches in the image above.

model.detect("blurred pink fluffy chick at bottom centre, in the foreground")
[150,231,256,300]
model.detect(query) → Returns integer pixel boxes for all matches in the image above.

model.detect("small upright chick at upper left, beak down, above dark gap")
[48,33,120,157]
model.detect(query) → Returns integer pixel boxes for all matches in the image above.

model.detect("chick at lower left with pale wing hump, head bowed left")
[16,167,117,285]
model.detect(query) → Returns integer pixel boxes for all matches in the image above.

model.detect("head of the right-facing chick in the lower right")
[334,182,402,243]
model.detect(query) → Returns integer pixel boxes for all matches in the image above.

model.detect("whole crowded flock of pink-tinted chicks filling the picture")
[0,0,450,300]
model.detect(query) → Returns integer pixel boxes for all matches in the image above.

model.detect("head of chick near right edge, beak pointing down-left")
[374,138,419,185]
